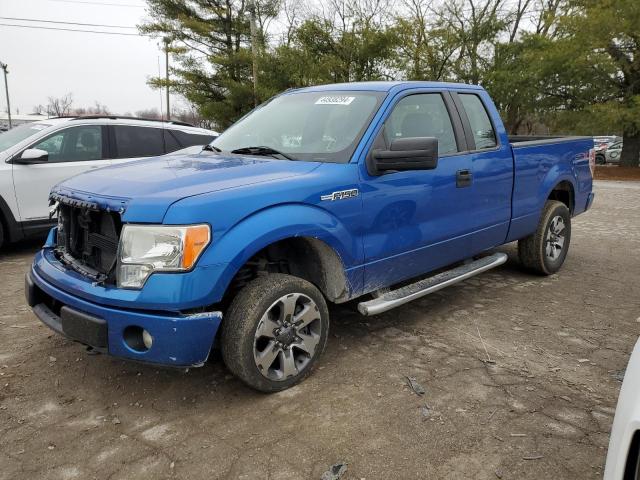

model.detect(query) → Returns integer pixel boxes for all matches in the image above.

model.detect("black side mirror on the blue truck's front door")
[371,137,438,172]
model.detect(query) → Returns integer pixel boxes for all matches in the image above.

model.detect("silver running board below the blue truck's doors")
[358,253,507,315]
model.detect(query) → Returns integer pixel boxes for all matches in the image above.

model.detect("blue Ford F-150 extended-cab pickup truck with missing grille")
[26,82,595,392]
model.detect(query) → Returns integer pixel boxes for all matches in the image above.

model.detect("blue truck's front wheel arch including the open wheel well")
[201,204,362,303]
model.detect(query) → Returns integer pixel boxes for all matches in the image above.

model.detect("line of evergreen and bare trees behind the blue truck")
[140,0,640,166]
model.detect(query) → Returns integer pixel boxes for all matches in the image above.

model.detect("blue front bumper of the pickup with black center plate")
[25,267,222,367]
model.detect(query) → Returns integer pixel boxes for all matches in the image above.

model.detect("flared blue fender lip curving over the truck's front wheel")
[201,204,362,302]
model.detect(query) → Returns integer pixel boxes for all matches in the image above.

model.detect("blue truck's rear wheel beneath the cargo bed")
[518,200,571,275]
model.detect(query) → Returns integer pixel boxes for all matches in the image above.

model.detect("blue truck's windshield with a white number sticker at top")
[211,91,384,163]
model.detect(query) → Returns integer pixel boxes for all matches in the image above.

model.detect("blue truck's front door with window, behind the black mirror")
[361,91,474,291]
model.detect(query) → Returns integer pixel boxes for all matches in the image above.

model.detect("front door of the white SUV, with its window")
[12,125,110,222]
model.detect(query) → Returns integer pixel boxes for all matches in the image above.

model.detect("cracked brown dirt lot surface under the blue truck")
[0,182,640,480]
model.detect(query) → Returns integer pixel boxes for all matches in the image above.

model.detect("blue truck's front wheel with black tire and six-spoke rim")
[220,273,329,393]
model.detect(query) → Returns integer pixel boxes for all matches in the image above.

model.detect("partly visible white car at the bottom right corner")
[604,340,640,480]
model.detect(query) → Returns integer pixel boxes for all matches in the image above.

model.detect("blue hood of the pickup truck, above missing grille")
[52,152,320,223]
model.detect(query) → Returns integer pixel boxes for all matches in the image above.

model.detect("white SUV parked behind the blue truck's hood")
[0,116,218,247]
